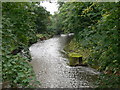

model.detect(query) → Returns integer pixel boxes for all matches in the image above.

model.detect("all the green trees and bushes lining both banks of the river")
[1,2,120,88]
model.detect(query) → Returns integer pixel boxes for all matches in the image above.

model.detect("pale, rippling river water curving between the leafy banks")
[29,35,99,88]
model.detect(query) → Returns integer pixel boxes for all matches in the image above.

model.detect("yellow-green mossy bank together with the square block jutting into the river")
[64,39,90,66]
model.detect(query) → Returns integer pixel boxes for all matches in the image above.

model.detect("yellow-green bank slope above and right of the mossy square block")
[64,39,99,70]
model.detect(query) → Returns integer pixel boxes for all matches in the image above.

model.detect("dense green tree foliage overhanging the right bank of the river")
[58,2,120,87]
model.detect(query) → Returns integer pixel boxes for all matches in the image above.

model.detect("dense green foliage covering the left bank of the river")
[2,2,49,87]
